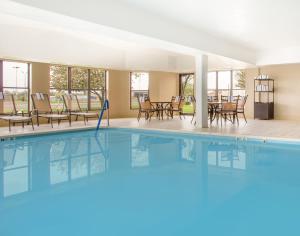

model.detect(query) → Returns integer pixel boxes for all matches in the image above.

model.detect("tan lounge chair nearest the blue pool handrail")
[62,94,99,125]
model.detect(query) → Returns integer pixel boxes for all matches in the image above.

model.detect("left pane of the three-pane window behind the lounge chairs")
[50,65,68,110]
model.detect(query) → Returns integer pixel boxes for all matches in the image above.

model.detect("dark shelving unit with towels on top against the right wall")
[254,79,274,120]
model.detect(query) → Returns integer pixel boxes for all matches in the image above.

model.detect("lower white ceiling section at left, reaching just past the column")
[0,1,253,72]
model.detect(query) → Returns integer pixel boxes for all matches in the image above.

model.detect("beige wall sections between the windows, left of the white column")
[0,60,179,125]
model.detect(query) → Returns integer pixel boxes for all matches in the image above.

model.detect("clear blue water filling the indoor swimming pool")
[0,129,300,236]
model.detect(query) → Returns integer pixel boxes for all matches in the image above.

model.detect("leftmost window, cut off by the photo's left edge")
[0,61,30,113]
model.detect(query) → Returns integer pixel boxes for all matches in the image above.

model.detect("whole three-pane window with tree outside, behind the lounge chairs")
[50,65,106,110]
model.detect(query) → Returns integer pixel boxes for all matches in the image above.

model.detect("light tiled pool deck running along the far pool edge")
[0,117,300,141]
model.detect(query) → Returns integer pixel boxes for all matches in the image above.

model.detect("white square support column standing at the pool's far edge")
[195,55,208,128]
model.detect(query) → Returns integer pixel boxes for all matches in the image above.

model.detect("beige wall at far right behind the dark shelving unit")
[246,64,300,120]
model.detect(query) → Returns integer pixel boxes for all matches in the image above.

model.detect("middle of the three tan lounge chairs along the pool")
[31,93,71,128]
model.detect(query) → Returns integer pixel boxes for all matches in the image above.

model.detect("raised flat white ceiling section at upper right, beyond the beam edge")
[119,0,300,51]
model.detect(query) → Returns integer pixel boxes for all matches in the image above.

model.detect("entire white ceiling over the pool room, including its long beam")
[0,0,300,72]
